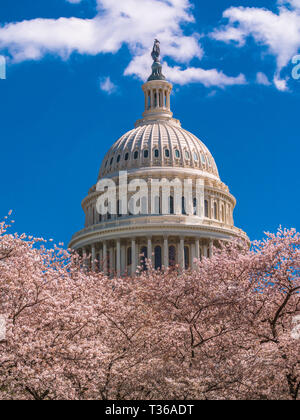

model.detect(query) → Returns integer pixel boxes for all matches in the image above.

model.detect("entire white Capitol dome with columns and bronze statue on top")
[69,40,249,276]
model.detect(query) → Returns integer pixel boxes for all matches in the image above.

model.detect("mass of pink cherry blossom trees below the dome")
[0,217,300,400]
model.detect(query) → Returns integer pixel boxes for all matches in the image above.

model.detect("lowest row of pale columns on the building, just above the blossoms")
[78,236,216,277]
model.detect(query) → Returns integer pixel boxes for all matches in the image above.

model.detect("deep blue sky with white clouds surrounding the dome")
[0,0,300,243]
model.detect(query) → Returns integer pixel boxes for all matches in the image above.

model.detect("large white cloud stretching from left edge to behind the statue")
[0,0,243,87]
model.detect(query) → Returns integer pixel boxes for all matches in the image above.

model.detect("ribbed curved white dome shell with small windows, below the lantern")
[99,119,219,179]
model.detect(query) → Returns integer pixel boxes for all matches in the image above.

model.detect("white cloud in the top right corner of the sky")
[211,0,300,90]
